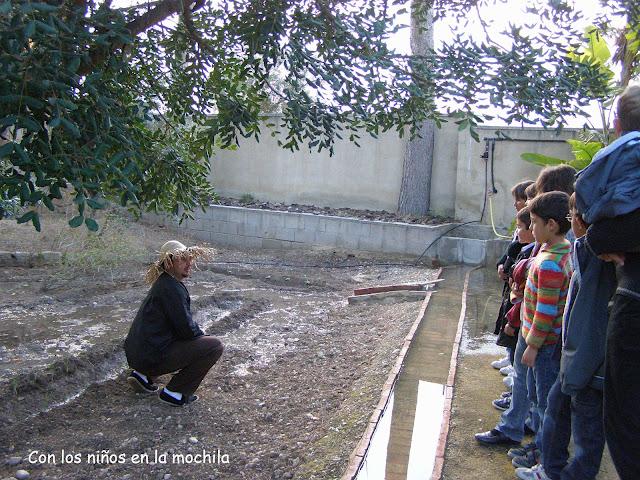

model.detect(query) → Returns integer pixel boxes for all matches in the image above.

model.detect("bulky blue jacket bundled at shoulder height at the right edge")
[575,131,640,224]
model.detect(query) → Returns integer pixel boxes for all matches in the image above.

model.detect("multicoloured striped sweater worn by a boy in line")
[522,240,571,348]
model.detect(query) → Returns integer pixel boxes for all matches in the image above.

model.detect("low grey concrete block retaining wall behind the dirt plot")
[145,205,504,265]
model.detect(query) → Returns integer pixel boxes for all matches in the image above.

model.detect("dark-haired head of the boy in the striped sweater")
[528,192,571,243]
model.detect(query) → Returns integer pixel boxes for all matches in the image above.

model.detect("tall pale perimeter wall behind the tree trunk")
[211,118,575,226]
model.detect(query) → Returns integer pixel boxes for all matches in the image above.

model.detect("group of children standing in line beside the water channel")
[475,86,640,480]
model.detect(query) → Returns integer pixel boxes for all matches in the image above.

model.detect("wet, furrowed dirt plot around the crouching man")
[0,210,435,480]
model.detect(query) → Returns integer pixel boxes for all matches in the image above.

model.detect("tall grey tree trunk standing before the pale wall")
[398,0,435,216]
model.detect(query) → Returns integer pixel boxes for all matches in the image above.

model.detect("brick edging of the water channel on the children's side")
[431,267,481,480]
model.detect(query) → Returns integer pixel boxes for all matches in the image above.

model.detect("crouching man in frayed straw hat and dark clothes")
[124,240,224,407]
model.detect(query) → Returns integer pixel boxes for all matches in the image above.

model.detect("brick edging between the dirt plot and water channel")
[341,268,442,480]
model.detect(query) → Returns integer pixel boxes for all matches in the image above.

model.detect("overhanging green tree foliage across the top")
[0,0,637,230]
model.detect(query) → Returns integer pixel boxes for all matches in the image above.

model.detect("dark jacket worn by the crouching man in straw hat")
[124,273,204,373]
